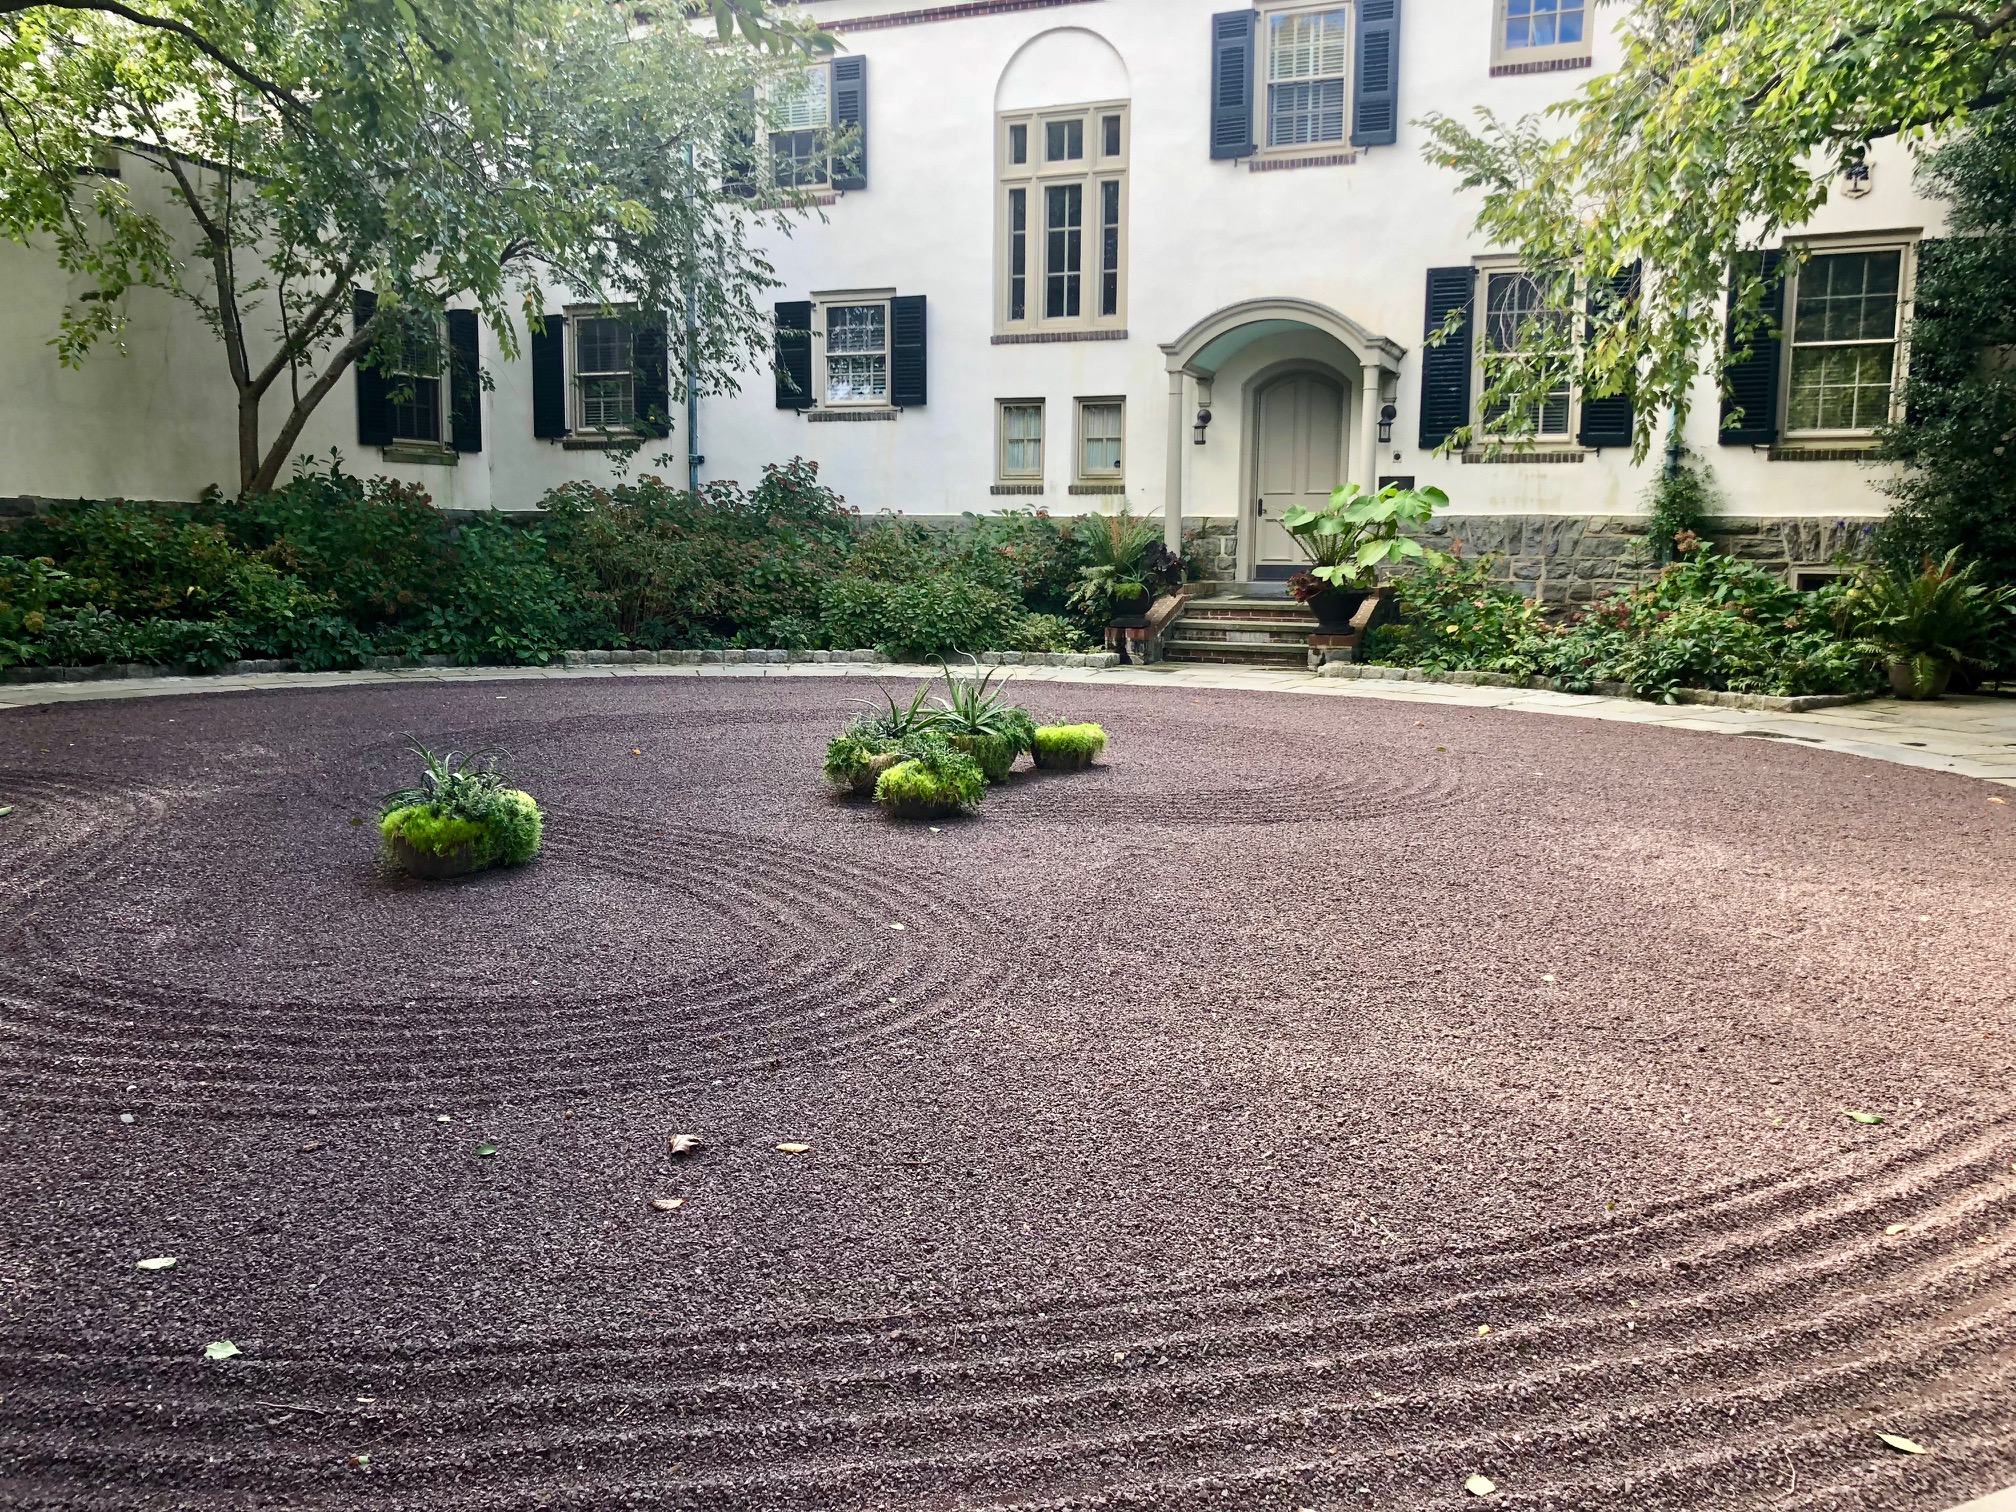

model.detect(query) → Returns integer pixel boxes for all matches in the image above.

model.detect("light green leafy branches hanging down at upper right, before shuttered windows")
[1425,0,2016,456]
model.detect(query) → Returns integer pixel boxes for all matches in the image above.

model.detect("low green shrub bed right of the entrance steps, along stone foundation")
[1365,532,1883,700]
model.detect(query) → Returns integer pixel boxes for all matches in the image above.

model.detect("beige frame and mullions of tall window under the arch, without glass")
[994,101,1133,335]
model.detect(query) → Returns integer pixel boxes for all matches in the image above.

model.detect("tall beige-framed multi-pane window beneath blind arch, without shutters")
[996,105,1127,335]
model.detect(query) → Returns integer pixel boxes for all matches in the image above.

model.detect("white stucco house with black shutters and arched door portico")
[0,0,1939,597]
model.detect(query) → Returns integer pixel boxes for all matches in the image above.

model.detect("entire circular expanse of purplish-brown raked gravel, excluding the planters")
[0,677,2016,1512]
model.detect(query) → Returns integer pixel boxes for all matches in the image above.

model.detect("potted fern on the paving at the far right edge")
[1841,546,2016,698]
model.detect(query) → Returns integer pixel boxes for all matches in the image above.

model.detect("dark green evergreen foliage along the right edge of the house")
[1877,113,2016,583]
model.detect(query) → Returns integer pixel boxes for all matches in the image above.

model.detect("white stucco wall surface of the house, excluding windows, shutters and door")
[0,0,1939,540]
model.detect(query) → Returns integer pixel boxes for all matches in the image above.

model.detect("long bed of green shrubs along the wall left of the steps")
[0,460,1099,669]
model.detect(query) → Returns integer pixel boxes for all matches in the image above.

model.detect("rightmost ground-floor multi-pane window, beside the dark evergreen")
[1784,248,1903,431]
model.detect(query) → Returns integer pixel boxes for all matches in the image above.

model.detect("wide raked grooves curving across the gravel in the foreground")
[0,1121,2016,1512]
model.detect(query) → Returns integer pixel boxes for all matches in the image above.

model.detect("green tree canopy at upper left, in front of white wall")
[0,0,823,492]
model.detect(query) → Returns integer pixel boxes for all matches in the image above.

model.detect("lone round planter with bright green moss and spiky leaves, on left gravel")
[379,740,546,877]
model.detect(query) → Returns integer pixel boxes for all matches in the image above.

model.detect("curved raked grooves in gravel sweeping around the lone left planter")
[0,814,988,1119]
